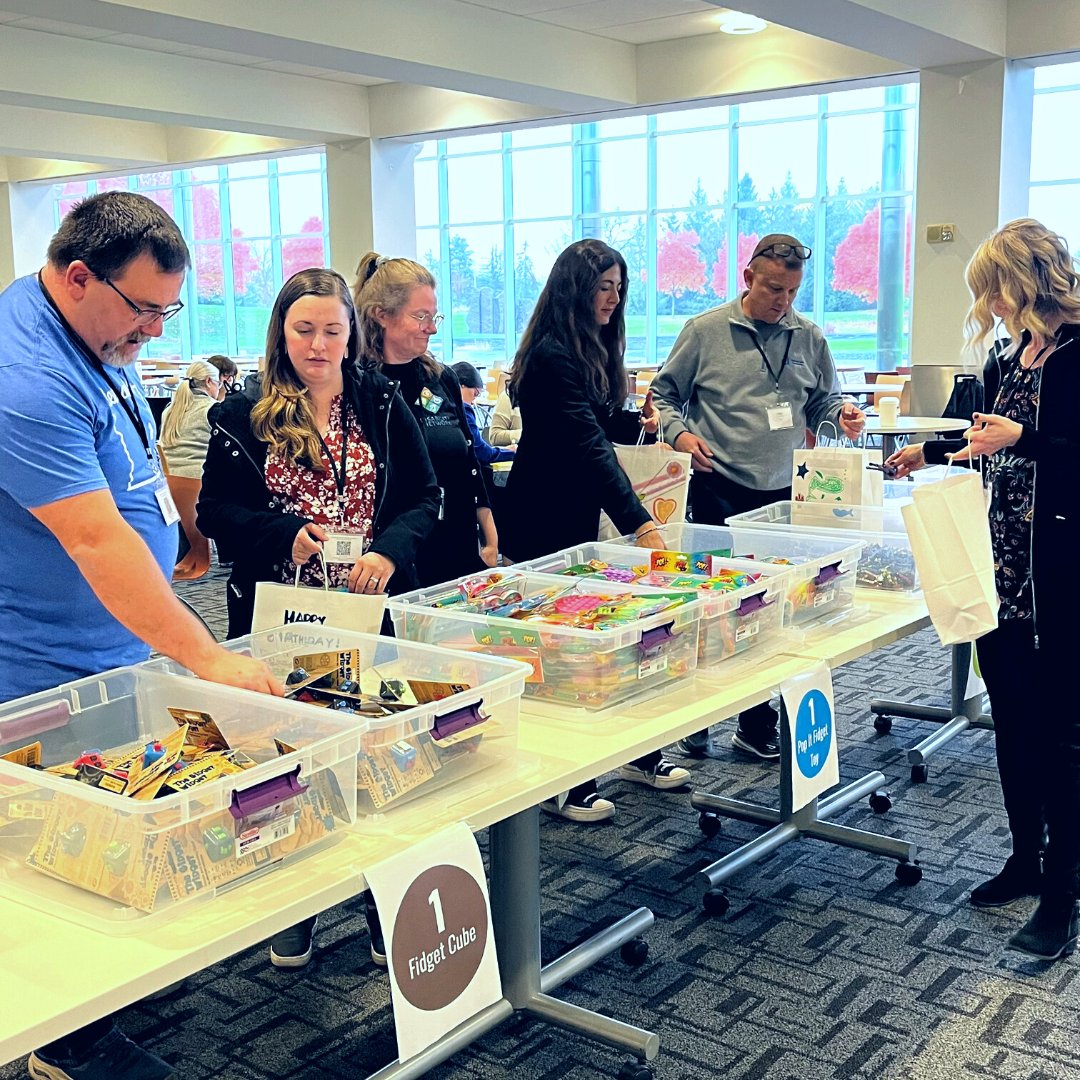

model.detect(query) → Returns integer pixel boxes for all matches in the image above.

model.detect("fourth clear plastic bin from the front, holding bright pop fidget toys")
[515,543,799,676]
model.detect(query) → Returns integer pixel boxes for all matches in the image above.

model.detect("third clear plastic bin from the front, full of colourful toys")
[389,569,702,713]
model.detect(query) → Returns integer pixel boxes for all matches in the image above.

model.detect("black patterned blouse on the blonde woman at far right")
[986,363,1042,619]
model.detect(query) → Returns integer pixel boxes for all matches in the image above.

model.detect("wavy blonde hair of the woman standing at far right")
[964,217,1080,353]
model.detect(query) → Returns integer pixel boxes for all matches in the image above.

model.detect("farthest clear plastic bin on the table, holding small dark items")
[728,499,919,593]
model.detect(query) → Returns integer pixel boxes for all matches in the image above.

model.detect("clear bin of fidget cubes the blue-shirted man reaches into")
[150,626,529,815]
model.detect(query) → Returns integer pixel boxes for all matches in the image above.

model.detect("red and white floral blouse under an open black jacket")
[266,394,375,589]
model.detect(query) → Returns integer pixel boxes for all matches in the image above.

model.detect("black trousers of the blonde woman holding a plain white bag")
[976,619,1080,897]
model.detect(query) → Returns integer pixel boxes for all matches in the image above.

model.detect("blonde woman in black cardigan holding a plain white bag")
[890,218,1080,960]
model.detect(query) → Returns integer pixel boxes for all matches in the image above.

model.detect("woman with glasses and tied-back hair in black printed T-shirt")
[353,252,499,585]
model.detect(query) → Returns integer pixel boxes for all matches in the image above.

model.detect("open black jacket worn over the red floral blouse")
[197,366,438,637]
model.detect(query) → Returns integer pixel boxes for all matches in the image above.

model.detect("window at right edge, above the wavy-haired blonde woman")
[1028,64,1080,255]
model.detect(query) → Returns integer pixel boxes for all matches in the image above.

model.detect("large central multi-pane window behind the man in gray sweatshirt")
[415,84,917,369]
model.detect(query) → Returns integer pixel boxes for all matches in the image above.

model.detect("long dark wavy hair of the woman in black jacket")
[508,240,627,408]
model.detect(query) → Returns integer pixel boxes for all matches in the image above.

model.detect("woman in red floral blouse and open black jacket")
[198,270,438,637]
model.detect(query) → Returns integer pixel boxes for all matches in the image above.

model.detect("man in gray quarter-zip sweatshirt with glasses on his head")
[652,233,864,760]
